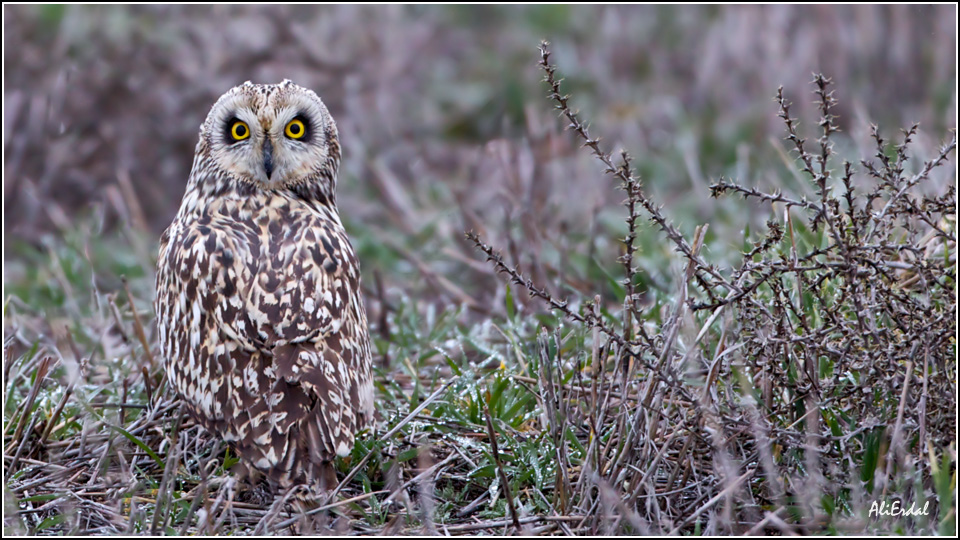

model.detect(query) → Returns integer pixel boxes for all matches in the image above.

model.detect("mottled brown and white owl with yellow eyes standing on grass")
[155,81,374,493]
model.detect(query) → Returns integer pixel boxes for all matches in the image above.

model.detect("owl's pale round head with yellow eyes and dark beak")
[195,80,340,202]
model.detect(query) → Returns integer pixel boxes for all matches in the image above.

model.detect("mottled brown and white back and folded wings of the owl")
[158,199,373,484]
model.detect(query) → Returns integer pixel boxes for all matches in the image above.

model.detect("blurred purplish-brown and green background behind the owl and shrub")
[3,5,957,300]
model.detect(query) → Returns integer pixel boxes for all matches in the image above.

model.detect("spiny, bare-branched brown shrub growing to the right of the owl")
[468,42,956,533]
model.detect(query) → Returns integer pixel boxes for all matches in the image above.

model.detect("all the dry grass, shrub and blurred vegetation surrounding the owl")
[4,6,957,535]
